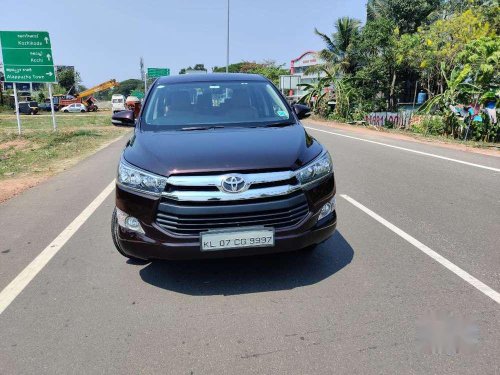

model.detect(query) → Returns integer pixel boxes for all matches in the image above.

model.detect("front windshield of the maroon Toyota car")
[141,81,293,130]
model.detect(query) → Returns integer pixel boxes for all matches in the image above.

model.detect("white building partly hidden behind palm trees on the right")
[280,51,325,100]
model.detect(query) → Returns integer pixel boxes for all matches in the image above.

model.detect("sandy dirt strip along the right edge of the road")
[305,119,500,157]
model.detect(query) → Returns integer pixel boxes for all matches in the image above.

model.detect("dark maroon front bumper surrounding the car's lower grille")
[116,175,337,260]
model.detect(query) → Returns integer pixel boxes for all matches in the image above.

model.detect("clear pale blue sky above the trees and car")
[0,0,366,87]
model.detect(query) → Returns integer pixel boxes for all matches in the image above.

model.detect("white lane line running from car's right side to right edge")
[340,194,500,304]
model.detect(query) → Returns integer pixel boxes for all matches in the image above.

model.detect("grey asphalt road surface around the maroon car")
[0,124,500,374]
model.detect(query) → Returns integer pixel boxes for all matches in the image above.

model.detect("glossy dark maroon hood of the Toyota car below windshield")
[123,124,322,177]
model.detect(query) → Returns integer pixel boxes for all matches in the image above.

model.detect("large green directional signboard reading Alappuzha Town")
[0,31,56,83]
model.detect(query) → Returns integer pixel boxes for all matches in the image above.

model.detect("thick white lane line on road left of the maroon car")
[0,180,115,315]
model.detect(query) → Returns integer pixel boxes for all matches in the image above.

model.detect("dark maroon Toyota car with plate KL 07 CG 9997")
[111,74,337,259]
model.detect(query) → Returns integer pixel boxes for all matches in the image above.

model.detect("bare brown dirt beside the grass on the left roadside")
[0,136,124,203]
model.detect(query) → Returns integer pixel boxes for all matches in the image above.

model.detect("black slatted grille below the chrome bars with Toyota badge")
[156,192,309,236]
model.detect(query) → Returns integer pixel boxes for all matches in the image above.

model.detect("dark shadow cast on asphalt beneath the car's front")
[140,231,354,296]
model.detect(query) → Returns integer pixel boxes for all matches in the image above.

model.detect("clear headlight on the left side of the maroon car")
[116,160,167,194]
